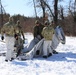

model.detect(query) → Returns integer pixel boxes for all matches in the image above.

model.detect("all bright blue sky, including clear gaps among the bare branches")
[1,0,74,17]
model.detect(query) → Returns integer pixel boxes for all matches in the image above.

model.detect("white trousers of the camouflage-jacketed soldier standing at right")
[43,40,52,56]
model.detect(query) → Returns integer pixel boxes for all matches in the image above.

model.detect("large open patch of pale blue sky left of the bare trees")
[1,0,35,16]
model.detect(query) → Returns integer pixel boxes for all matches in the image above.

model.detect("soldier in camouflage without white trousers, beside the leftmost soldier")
[14,20,25,57]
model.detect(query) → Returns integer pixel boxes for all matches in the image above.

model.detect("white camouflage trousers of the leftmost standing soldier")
[5,36,15,60]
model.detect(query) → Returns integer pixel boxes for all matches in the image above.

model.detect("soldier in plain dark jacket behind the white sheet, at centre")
[34,20,44,43]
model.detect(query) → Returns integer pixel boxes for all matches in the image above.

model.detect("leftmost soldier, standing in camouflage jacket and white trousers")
[1,17,15,62]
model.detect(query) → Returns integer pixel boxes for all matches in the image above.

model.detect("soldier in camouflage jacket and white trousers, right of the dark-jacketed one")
[42,21,55,58]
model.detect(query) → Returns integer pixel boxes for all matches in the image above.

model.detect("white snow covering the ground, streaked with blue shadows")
[0,33,76,75]
